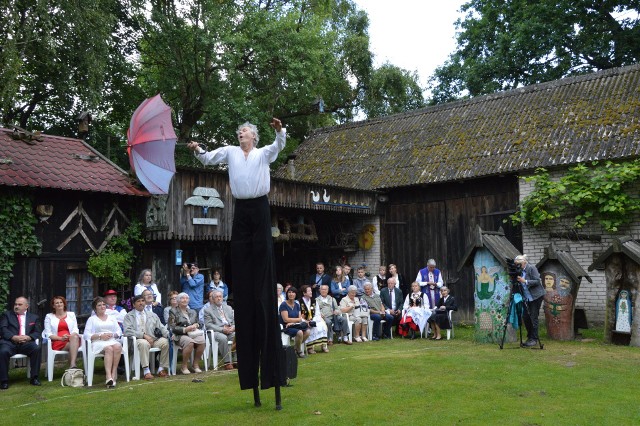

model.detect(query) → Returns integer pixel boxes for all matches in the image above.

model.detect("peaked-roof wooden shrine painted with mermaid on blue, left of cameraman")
[458,226,520,343]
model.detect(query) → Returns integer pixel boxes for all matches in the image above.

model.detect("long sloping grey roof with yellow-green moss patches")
[275,65,640,190]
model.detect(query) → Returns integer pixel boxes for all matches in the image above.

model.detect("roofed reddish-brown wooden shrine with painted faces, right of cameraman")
[536,243,592,340]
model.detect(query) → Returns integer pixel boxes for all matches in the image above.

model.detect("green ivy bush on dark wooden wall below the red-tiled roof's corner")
[87,220,144,288]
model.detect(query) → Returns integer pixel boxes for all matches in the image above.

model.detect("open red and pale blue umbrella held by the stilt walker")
[127,94,177,194]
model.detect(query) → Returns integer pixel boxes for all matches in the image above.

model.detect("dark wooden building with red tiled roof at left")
[0,129,149,319]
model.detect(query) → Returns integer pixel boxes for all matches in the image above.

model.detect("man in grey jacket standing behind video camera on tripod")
[513,255,544,347]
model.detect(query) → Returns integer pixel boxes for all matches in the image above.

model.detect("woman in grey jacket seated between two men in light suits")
[169,292,205,374]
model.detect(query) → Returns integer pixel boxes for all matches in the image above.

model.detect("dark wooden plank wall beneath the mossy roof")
[381,176,522,322]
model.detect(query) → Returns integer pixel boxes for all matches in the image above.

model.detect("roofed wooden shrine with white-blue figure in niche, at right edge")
[589,237,640,346]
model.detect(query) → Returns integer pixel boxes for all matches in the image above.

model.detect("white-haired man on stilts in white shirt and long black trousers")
[187,118,286,410]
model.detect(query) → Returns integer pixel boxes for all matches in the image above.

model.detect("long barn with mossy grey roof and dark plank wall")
[275,65,640,321]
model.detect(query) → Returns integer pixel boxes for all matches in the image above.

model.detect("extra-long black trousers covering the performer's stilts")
[231,195,282,389]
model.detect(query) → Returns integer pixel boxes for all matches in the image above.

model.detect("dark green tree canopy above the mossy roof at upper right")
[431,0,640,103]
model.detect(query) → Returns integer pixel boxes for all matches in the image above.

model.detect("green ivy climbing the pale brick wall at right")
[510,160,640,232]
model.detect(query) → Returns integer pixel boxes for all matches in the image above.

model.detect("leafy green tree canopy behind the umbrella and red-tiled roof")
[0,0,423,170]
